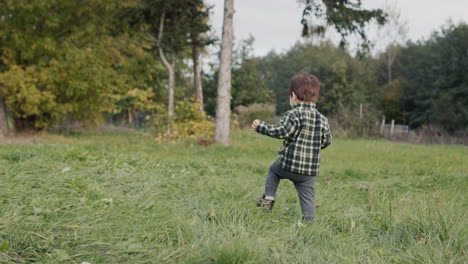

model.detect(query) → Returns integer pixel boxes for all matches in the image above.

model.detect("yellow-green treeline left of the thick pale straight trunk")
[0,0,214,138]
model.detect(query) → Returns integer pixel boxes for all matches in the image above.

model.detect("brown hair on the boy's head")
[289,72,320,103]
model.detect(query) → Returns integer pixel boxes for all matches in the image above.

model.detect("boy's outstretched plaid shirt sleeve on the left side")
[257,112,298,139]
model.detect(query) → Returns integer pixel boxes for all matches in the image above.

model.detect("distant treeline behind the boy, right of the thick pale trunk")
[205,23,468,134]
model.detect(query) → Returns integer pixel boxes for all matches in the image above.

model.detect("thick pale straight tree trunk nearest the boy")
[215,0,234,145]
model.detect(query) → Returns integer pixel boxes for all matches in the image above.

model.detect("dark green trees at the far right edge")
[399,23,468,132]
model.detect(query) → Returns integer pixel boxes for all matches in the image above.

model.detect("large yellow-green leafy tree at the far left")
[0,0,125,131]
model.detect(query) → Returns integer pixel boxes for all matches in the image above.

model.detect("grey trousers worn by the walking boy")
[265,162,315,222]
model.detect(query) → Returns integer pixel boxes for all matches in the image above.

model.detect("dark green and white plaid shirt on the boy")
[257,102,332,176]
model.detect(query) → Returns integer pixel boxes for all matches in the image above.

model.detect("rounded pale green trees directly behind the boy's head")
[261,42,379,115]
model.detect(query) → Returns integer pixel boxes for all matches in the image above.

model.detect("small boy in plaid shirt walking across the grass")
[252,73,332,224]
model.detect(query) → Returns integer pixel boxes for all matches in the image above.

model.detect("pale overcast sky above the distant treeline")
[207,0,468,56]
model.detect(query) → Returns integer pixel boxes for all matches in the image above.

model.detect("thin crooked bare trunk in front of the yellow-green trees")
[158,11,176,135]
